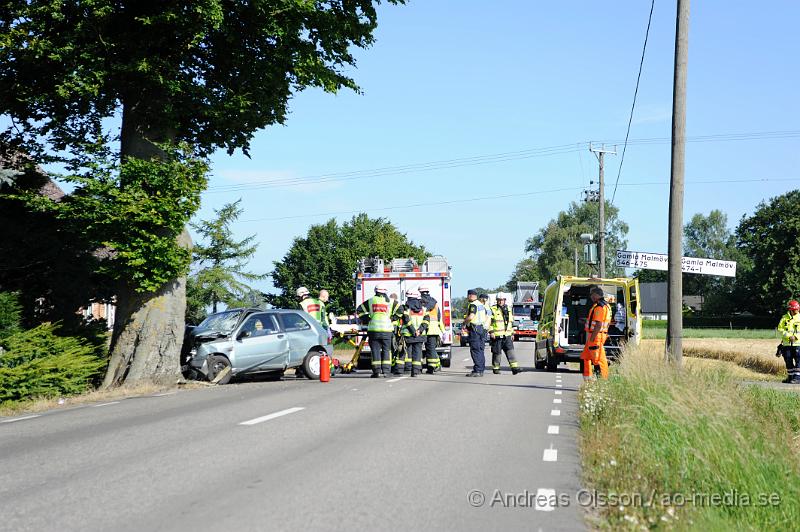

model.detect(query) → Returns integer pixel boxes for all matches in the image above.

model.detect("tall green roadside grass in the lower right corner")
[580,344,800,530]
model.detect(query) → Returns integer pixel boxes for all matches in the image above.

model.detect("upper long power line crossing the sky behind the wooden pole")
[206,130,800,194]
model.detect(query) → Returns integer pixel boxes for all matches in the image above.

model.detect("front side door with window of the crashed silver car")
[231,312,289,373]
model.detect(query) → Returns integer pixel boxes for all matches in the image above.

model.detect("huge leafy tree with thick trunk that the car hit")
[0,0,403,386]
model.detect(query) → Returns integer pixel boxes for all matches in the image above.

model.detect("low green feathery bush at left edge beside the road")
[0,323,106,404]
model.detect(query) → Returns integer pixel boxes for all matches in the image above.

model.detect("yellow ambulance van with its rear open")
[534,275,642,371]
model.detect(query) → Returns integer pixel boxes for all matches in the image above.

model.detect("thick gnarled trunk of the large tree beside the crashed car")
[103,104,192,388]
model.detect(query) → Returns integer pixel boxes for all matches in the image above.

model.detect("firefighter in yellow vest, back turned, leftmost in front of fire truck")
[356,284,400,378]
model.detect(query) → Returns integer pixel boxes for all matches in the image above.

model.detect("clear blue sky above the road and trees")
[198,0,800,295]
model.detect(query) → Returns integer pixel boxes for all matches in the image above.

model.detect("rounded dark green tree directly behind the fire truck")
[270,213,429,313]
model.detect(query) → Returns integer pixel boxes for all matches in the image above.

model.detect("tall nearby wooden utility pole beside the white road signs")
[666,0,689,367]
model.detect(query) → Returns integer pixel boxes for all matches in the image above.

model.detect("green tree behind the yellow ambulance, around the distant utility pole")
[515,202,628,286]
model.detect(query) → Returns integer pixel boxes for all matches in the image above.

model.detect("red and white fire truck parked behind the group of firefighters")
[353,255,453,369]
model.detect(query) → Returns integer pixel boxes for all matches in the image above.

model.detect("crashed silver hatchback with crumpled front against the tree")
[182,309,333,384]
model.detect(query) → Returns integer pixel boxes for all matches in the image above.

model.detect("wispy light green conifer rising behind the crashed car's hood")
[186,200,267,317]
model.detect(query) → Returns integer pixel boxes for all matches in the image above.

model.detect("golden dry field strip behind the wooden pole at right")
[642,338,786,380]
